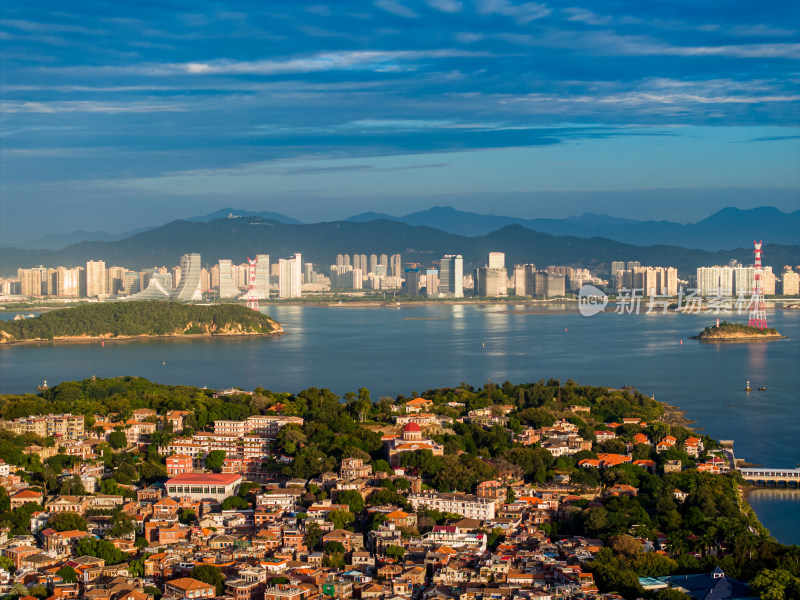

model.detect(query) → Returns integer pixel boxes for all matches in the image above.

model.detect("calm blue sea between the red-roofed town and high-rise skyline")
[0,305,800,543]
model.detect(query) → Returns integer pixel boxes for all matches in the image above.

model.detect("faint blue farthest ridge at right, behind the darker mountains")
[347,206,800,250]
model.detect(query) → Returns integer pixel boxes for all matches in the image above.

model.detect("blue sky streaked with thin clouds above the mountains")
[0,0,800,245]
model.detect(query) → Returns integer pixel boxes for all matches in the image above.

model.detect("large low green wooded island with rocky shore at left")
[0,300,283,344]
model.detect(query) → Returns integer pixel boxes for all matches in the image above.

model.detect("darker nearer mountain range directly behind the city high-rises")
[0,217,800,274]
